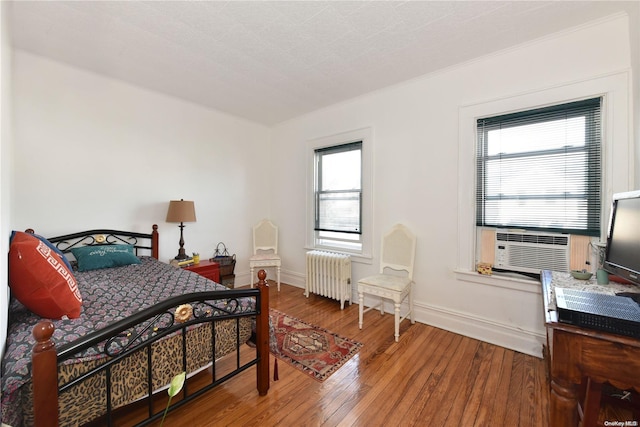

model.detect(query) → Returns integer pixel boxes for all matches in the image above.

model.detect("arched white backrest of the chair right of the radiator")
[380,224,416,279]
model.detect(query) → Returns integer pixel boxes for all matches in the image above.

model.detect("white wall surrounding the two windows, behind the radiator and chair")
[272,16,633,355]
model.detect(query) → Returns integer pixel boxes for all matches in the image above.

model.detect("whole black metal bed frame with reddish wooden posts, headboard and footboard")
[27,225,269,426]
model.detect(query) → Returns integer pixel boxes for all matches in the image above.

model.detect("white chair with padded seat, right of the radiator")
[358,224,416,342]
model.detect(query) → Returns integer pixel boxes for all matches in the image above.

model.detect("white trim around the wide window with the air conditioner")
[455,69,634,281]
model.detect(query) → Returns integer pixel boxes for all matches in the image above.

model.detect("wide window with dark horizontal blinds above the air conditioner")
[476,98,602,236]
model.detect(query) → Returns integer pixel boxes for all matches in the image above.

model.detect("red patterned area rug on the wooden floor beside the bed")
[269,309,362,381]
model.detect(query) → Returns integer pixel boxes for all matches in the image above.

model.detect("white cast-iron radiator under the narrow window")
[304,251,351,310]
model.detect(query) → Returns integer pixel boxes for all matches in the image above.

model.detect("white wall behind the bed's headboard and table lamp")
[11,50,271,283]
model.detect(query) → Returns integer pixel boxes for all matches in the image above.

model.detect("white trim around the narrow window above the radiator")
[305,127,374,262]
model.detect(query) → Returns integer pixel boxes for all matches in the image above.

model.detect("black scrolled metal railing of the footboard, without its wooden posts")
[58,289,261,426]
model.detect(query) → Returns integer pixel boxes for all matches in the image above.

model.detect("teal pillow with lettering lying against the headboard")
[71,245,140,271]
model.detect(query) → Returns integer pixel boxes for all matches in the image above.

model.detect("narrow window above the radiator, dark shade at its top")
[314,141,362,251]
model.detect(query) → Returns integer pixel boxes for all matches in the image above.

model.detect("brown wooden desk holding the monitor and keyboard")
[541,271,640,427]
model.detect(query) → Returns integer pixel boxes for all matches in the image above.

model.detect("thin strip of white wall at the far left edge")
[0,2,12,356]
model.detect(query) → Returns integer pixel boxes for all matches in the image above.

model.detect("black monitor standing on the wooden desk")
[604,192,640,284]
